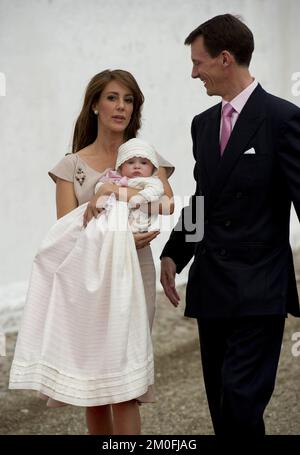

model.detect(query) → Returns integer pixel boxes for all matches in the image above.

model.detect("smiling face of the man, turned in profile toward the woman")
[191,36,224,96]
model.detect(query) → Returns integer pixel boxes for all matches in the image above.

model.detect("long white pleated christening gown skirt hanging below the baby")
[9,201,155,406]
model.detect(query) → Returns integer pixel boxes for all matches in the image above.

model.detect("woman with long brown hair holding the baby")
[11,70,173,434]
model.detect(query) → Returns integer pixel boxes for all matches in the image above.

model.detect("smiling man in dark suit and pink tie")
[161,14,300,436]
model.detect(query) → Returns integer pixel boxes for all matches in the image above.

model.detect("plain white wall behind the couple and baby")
[0,0,300,298]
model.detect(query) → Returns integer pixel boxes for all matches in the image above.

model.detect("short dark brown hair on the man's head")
[184,14,254,67]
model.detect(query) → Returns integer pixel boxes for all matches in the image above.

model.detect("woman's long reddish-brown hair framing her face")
[72,70,144,153]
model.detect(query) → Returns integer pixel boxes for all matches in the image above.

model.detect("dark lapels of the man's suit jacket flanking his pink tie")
[206,85,266,213]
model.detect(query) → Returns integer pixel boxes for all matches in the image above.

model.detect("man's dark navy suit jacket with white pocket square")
[161,85,300,317]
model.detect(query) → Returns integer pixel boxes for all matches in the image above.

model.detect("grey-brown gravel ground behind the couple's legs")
[0,252,300,435]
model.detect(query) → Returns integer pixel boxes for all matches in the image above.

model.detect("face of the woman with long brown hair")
[93,81,134,133]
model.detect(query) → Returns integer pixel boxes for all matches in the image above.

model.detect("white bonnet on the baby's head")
[116,137,159,175]
